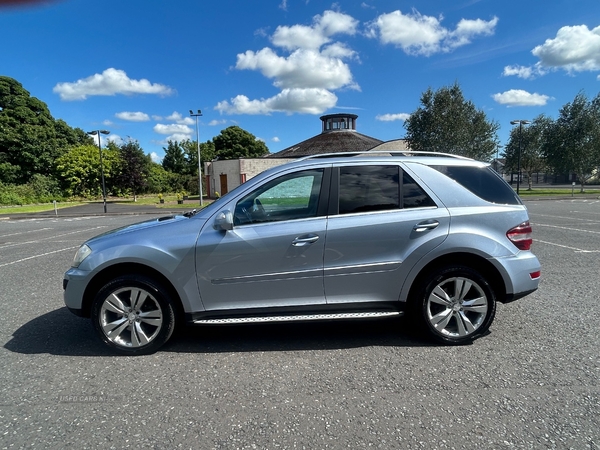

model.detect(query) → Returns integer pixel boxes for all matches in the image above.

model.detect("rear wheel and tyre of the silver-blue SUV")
[413,265,496,345]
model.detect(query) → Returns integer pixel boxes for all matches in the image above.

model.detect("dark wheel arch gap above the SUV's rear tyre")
[401,252,506,303]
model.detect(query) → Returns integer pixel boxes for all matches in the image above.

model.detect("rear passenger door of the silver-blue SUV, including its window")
[324,164,450,304]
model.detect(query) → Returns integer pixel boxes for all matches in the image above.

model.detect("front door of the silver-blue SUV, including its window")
[196,168,330,310]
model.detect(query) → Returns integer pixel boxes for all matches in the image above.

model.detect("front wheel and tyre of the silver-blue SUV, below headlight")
[91,275,175,355]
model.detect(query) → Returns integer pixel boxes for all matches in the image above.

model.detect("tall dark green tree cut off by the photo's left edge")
[0,76,93,184]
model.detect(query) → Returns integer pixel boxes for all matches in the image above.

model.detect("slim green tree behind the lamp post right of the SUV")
[503,115,552,190]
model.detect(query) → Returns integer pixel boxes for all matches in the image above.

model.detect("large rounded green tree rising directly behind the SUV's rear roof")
[404,83,500,161]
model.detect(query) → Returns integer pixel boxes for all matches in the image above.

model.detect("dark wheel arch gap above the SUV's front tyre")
[82,262,184,326]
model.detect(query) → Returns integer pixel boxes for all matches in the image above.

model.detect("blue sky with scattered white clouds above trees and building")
[0,0,600,160]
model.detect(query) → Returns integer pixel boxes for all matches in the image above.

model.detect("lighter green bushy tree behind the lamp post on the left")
[56,145,122,198]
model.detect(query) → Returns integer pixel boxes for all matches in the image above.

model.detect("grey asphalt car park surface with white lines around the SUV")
[0,199,600,449]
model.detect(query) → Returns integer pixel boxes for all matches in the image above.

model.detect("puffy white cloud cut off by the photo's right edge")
[531,25,600,72]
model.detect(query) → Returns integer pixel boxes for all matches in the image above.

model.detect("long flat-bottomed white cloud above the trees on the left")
[52,68,174,101]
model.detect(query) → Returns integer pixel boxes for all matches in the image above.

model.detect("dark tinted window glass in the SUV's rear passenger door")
[338,165,437,214]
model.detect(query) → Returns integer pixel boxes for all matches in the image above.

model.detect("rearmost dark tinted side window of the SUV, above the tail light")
[431,166,521,205]
